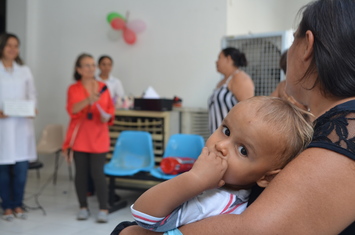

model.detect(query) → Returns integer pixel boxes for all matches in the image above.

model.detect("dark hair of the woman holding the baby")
[295,0,355,98]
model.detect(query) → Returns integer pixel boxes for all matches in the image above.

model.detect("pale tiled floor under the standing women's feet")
[0,156,140,235]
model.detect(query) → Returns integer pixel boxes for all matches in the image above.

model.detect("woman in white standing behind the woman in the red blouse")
[96,55,124,104]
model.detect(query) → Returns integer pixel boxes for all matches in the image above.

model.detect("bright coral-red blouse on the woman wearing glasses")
[63,81,115,153]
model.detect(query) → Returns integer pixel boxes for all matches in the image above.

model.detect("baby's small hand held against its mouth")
[189,147,228,190]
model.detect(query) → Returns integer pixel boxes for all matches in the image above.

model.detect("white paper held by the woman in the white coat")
[4,100,36,117]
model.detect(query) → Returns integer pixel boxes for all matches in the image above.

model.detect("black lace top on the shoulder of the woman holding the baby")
[308,100,355,160]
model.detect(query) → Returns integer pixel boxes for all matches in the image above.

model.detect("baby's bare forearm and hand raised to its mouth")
[133,148,227,217]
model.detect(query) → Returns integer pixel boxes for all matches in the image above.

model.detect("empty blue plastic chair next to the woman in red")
[104,131,155,176]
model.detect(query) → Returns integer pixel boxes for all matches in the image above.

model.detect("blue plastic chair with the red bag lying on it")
[150,134,205,180]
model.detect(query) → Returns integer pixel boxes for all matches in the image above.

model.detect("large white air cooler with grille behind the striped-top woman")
[222,30,293,95]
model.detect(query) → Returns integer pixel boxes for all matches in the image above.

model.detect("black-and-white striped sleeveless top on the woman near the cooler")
[208,74,238,134]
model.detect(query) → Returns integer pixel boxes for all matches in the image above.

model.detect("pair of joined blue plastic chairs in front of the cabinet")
[104,131,205,180]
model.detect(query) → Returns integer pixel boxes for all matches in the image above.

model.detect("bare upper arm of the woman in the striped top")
[228,72,255,101]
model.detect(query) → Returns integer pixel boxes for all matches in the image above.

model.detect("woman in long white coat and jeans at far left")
[0,33,37,221]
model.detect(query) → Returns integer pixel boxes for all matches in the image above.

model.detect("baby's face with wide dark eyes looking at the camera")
[206,101,281,188]
